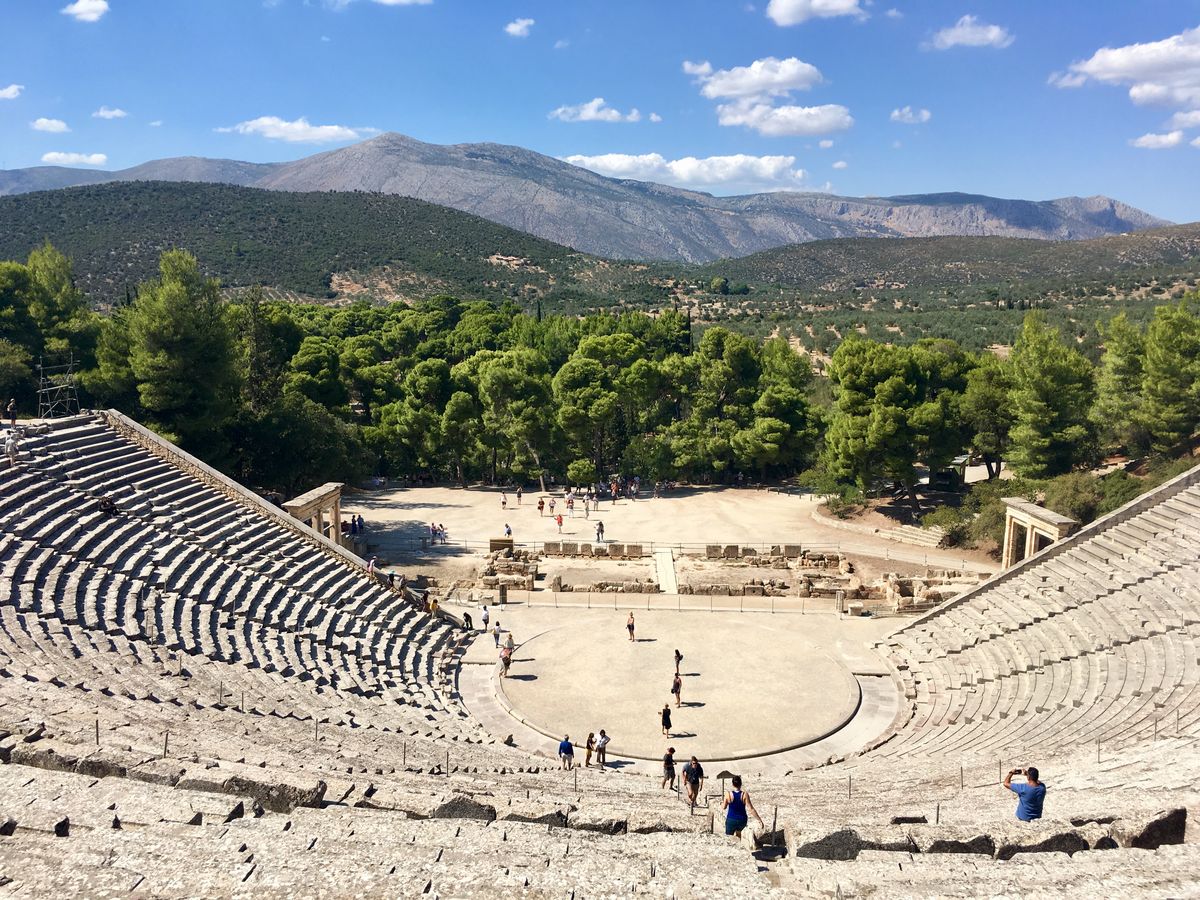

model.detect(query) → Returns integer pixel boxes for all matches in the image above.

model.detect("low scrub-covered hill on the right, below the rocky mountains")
[700,223,1200,293]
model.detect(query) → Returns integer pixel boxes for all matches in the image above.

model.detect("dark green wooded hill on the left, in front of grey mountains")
[0,181,607,302]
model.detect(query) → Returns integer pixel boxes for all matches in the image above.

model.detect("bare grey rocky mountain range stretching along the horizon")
[0,133,1170,262]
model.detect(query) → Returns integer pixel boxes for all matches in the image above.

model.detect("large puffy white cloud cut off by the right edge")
[1050,26,1200,107]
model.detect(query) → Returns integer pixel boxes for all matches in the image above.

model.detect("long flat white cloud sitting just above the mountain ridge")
[564,154,808,191]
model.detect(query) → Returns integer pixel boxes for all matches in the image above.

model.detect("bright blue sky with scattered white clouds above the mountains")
[0,0,1200,221]
